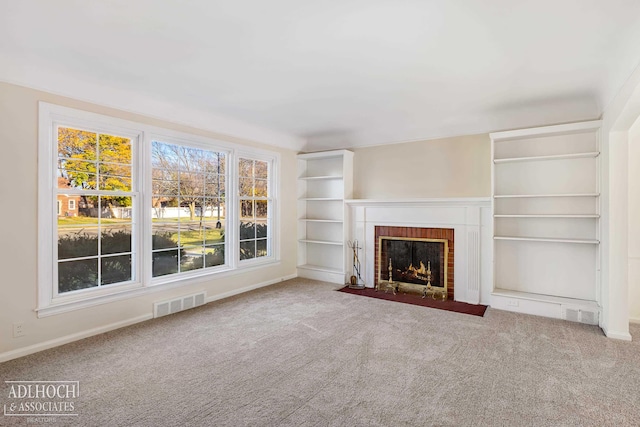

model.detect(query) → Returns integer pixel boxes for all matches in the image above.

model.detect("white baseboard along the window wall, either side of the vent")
[0,274,297,363]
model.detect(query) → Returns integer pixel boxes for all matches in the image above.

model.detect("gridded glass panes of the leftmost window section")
[55,126,136,294]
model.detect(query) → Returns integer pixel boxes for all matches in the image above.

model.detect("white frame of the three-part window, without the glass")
[36,102,280,317]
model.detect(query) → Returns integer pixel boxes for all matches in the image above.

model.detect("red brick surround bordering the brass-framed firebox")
[373,226,454,301]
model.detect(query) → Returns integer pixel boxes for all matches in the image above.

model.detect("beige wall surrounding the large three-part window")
[0,83,296,360]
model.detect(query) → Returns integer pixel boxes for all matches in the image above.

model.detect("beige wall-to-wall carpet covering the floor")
[0,279,640,426]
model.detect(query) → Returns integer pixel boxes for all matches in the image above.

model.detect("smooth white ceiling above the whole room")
[0,0,640,151]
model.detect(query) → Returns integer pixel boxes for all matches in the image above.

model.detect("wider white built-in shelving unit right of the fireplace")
[490,121,600,324]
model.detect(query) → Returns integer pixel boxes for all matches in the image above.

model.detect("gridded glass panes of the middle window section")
[151,141,227,277]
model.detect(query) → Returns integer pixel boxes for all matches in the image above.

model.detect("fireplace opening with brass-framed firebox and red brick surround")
[374,226,454,300]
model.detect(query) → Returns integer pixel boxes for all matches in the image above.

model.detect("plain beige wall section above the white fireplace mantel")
[354,134,491,199]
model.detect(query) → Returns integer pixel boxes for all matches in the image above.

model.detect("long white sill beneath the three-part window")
[35,258,280,318]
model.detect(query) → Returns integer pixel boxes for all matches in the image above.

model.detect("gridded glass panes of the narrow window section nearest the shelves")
[238,157,271,261]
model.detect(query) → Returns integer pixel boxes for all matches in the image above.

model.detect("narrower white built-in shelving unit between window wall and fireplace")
[298,150,353,284]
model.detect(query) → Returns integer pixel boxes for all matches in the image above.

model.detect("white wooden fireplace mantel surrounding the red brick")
[345,197,493,304]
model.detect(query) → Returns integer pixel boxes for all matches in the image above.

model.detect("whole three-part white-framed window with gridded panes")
[38,103,277,315]
